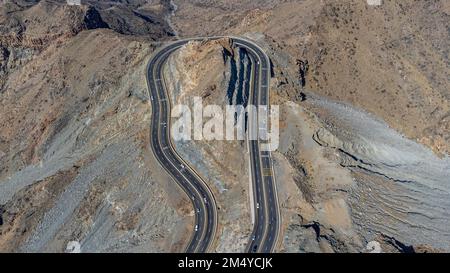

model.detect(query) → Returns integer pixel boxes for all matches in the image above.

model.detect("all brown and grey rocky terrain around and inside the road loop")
[0,0,450,252]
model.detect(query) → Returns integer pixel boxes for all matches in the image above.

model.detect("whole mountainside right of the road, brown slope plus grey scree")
[171,0,450,252]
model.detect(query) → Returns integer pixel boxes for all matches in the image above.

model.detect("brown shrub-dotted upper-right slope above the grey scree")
[172,0,450,155]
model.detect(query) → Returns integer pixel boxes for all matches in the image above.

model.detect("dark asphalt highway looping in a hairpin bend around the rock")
[147,37,280,252]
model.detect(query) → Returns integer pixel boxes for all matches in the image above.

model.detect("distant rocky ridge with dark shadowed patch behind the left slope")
[0,0,173,89]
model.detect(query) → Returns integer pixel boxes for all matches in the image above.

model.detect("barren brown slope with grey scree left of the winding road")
[0,1,193,252]
